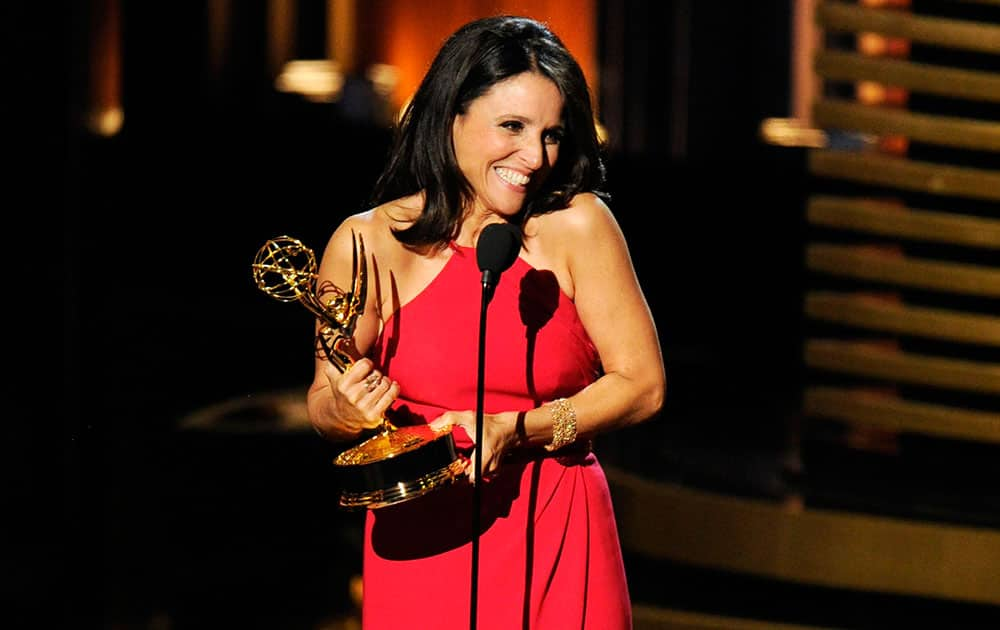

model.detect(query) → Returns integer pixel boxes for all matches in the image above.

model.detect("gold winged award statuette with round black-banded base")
[253,234,465,509]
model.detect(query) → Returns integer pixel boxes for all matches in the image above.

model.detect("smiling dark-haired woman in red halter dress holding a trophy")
[307,16,665,630]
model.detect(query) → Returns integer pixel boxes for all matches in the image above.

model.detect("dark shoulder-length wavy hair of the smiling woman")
[371,15,607,247]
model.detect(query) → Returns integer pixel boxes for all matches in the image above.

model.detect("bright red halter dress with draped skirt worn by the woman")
[362,245,631,630]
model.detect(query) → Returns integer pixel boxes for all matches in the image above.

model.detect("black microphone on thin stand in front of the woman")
[469,223,521,630]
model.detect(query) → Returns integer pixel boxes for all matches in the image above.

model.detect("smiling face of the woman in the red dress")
[452,72,563,217]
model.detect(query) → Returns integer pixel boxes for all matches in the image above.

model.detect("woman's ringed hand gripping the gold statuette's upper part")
[321,358,399,436]
